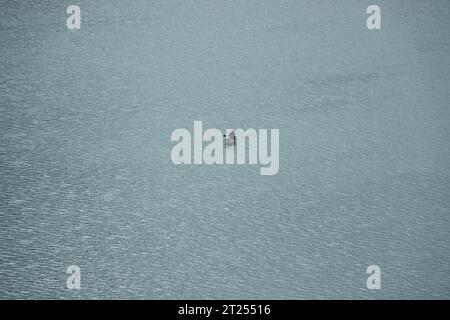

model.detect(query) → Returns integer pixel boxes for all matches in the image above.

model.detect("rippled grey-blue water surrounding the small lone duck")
[0,0,450,299]
